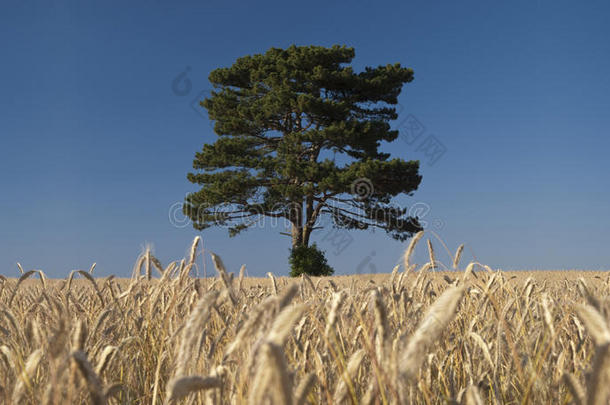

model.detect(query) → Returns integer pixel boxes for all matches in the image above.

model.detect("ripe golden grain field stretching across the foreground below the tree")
[0,235,610,404]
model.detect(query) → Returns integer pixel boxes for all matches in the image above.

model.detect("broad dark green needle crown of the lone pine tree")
[184,45,421,274]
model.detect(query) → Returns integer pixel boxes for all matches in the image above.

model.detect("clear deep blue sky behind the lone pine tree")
[0,1,610,277]
